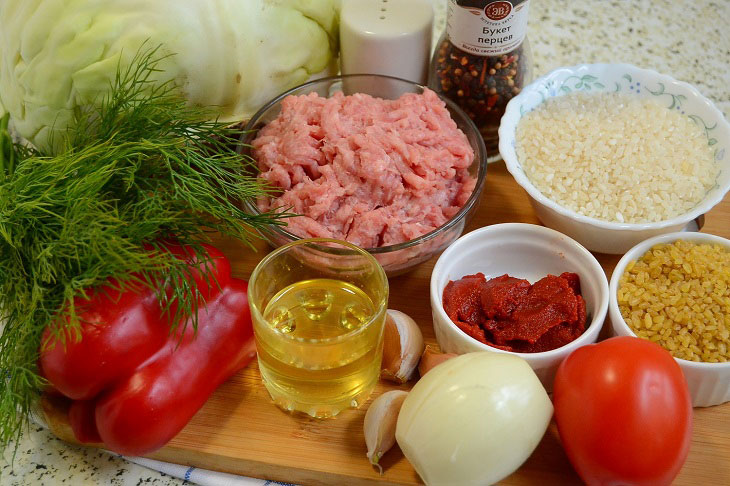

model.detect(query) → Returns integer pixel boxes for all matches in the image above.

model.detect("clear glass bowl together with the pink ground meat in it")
[240,74,487,276]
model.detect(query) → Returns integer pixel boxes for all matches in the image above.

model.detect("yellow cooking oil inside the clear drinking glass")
[256,278,385,417]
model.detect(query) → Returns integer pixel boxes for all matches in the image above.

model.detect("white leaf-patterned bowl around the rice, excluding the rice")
[499,64,730,254]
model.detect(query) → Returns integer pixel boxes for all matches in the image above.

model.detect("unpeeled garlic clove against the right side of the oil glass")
[380,309,425,383]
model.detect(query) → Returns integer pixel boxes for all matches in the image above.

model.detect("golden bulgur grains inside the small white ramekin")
[617,240,730,363]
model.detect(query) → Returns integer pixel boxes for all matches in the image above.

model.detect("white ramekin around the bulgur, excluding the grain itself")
[608,233,730,407]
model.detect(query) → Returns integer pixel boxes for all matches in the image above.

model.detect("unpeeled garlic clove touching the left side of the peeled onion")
[363,390,408,474]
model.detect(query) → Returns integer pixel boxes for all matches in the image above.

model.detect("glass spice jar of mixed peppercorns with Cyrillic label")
[429,0,532,162]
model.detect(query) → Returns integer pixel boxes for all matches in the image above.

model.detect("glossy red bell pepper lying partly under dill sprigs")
[40,246,255,455]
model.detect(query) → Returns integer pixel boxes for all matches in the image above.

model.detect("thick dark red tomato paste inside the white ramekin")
[443,272,586,353]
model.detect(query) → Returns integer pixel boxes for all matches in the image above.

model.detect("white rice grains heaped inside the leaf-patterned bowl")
[515,93,719,223]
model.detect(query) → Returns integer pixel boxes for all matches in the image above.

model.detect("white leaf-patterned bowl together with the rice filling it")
[499,64,730,254]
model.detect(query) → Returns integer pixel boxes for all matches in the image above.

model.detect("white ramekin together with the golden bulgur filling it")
[609,232,730,407]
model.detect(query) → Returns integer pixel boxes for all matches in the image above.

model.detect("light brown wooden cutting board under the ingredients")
[41,162,730,486]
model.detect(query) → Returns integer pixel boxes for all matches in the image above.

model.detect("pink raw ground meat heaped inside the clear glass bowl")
[252,90,476,248]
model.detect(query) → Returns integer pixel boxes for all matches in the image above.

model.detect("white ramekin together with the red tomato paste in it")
[430,223,608,391]
